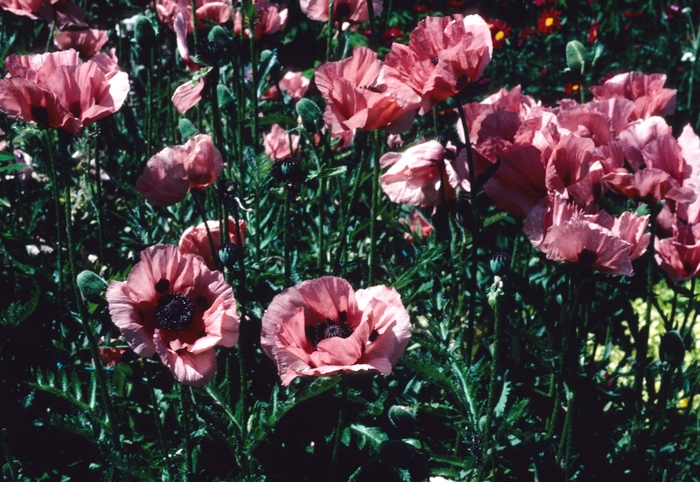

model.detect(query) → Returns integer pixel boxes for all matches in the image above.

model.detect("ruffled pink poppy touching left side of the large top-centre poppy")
[315,47,414,134]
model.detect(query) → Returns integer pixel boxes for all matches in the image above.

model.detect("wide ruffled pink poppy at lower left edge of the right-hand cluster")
[525,194,651,276]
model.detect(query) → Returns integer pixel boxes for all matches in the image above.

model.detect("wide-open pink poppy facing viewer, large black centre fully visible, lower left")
[107,244,239,387]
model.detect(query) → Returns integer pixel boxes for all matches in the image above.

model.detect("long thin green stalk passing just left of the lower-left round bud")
[64,157,121,451]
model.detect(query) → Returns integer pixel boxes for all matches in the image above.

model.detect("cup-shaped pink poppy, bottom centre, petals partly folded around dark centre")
[261,276,411,385]
